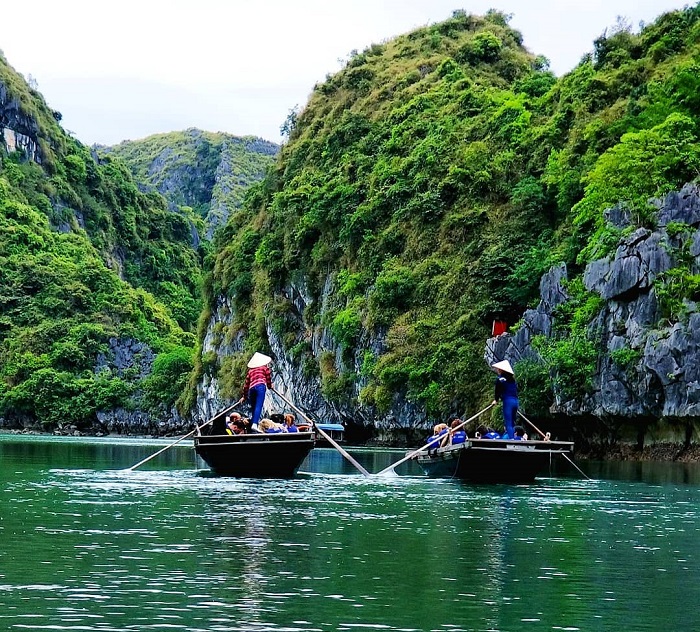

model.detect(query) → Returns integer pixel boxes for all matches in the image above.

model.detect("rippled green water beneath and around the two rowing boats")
[0,435,700,632]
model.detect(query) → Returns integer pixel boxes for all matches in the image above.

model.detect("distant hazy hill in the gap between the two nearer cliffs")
[102,128,280,239]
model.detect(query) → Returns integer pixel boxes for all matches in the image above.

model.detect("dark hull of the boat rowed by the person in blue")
[416,439,574,483]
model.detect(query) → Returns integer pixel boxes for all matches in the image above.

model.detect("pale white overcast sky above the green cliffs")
[0,0,686,145]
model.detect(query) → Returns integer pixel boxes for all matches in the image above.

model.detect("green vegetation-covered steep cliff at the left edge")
[0,56,201,428]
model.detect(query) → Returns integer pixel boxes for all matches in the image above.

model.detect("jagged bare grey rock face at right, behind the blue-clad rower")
[486,185,700,443]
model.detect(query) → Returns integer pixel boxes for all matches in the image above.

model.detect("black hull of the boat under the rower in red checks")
[194,432,315,478]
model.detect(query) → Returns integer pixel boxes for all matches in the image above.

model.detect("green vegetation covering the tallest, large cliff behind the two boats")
[201,6,700,415]
